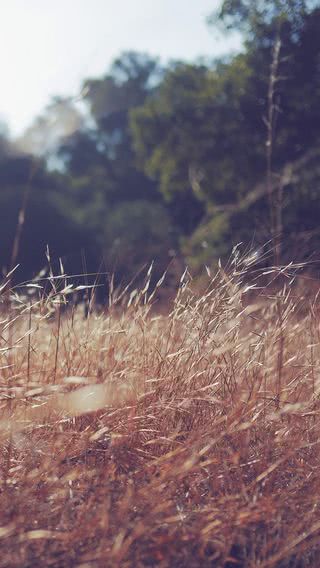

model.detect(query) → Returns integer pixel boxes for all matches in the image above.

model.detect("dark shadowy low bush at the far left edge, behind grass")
[0,156,90,280]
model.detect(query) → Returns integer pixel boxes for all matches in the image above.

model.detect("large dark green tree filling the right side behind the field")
[131,1,320,268]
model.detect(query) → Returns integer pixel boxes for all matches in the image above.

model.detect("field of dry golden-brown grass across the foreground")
[0,260,320,568]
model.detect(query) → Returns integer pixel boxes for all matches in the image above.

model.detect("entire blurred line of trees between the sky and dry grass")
[0,0,320,292]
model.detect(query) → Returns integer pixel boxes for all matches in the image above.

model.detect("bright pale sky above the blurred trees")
[0,0,240,137]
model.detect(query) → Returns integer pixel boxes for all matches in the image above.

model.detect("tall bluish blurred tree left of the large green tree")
[55,52,174,284]
